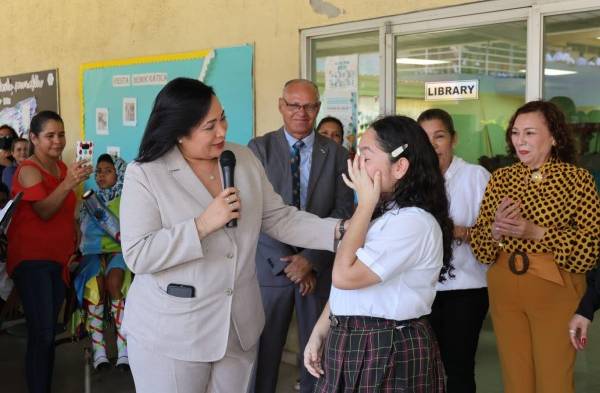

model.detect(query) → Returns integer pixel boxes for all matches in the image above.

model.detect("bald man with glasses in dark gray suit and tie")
[248,79,354,393]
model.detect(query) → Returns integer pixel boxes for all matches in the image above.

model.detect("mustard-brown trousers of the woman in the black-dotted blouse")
[488,252,586,393]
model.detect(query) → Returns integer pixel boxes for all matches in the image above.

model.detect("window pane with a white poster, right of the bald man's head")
[311,31,379,152]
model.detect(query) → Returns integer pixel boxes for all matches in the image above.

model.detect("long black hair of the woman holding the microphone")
[135,78,215,162]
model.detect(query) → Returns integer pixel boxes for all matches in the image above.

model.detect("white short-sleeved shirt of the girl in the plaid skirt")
[329,207,443,321]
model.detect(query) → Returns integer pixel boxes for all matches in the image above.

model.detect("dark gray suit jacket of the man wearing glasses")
[248,128,354,296]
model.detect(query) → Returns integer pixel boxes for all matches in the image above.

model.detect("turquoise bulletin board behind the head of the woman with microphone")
[80,45,254,162]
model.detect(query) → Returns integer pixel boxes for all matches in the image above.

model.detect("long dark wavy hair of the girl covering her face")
[371,116,454,282]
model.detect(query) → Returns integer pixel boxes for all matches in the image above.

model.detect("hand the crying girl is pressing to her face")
[342,155,381,209]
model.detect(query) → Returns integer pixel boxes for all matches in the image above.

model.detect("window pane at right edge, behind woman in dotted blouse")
[543,11,600,185]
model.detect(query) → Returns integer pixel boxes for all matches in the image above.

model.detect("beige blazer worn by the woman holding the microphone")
[120,144,337,362]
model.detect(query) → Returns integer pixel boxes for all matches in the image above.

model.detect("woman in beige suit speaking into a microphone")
[121,78,339,393]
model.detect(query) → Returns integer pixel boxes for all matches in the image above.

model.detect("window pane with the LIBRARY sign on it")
[396,21,527,168]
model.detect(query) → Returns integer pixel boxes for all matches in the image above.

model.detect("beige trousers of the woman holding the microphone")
[127,325,257,393]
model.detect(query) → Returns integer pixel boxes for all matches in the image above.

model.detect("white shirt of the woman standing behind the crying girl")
[437,156,490,291]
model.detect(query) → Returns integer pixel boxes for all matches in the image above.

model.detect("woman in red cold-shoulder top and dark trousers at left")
[7,111,92,393]
